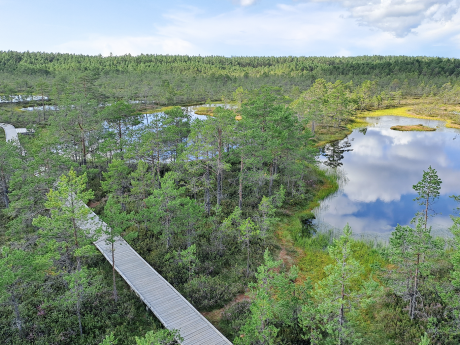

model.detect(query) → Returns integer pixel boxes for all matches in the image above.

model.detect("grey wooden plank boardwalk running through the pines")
[0,123,232,345]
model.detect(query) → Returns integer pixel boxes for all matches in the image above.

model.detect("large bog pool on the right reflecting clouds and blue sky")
[315,116,460,238]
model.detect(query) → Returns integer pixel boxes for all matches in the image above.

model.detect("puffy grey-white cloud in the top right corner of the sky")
[309,0,459,37]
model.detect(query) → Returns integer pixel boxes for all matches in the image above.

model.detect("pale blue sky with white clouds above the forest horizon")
[0,0,460,57]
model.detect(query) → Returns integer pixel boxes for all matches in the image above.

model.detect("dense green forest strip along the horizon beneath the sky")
[0,51,460,77]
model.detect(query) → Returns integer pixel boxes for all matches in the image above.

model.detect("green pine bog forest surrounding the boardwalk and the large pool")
[0,51,460,345]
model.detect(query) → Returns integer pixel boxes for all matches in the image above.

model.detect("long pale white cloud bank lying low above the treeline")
[52,0,460,56]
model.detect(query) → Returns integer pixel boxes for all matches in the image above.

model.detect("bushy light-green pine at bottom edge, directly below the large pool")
[301,224,379,345]
